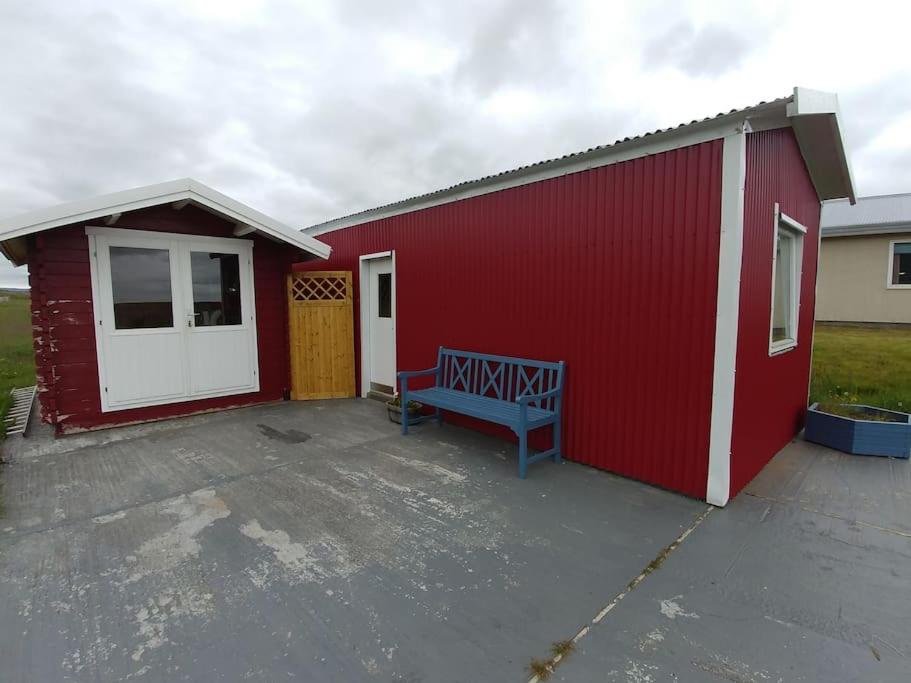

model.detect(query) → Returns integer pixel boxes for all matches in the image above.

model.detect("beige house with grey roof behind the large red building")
[816,193,911,324]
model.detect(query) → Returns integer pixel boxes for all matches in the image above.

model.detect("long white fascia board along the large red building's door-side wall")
[304,101,789,236]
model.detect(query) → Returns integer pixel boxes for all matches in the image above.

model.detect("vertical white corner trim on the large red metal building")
[705,123,747,506]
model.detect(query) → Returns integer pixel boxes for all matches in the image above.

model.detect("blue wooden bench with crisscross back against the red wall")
[398,346,563,479]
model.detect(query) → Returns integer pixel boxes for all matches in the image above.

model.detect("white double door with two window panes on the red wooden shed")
[86,228,259,412]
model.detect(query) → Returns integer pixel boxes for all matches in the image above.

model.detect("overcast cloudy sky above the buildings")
[0,0,911,286]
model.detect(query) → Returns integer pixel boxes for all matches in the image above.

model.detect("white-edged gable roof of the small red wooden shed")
[0,178,332,265]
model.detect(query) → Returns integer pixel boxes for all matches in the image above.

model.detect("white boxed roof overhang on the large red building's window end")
[787,88,857,204]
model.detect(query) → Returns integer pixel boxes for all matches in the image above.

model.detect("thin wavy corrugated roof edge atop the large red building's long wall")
[304,95,794,235]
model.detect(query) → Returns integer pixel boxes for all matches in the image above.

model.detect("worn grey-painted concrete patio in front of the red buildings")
[0,400,911,683]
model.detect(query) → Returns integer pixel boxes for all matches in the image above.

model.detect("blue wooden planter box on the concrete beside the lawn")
[804,403,911,458]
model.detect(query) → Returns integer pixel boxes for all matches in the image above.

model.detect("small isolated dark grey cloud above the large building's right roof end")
[643,20,753,76]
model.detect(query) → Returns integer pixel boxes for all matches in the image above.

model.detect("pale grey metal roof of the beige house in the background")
[821,193,911,237]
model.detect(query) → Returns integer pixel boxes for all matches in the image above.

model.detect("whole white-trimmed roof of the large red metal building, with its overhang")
[304,88,855,236]
